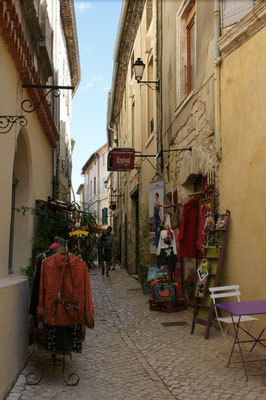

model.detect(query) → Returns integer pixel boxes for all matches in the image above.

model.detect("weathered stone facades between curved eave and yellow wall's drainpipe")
[109,1,218,273]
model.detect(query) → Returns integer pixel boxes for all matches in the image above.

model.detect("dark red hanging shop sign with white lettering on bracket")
[107,147,135,171]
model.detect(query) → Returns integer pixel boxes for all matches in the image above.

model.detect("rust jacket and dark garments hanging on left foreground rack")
[29,250,94,353]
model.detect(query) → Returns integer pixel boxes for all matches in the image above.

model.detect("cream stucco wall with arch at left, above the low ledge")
[0,37,52,278]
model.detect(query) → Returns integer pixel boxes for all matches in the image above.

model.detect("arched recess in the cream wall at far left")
[8,129,33,274]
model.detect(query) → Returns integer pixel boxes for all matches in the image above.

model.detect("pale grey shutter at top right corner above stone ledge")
[221,0,254,28]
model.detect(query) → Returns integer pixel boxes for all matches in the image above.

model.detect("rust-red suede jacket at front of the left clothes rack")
[37,253,94,328]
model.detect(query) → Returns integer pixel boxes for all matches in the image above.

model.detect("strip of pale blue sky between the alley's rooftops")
[71,0,122,196]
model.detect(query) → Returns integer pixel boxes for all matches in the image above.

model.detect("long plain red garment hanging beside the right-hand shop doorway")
[179,198,199,258]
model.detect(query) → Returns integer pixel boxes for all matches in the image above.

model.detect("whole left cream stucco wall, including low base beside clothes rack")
[0,28,52,400]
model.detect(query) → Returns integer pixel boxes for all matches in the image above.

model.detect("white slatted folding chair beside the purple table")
[209,285,258,343]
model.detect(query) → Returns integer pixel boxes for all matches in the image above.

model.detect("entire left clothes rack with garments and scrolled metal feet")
[26,245,94,386]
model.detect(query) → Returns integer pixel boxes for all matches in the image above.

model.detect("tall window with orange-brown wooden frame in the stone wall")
[176,0,196,107]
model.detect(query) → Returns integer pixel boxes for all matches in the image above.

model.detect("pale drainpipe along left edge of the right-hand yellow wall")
[213,0,222,160]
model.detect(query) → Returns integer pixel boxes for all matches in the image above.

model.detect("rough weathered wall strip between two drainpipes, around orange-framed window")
[162,1,219,203]
